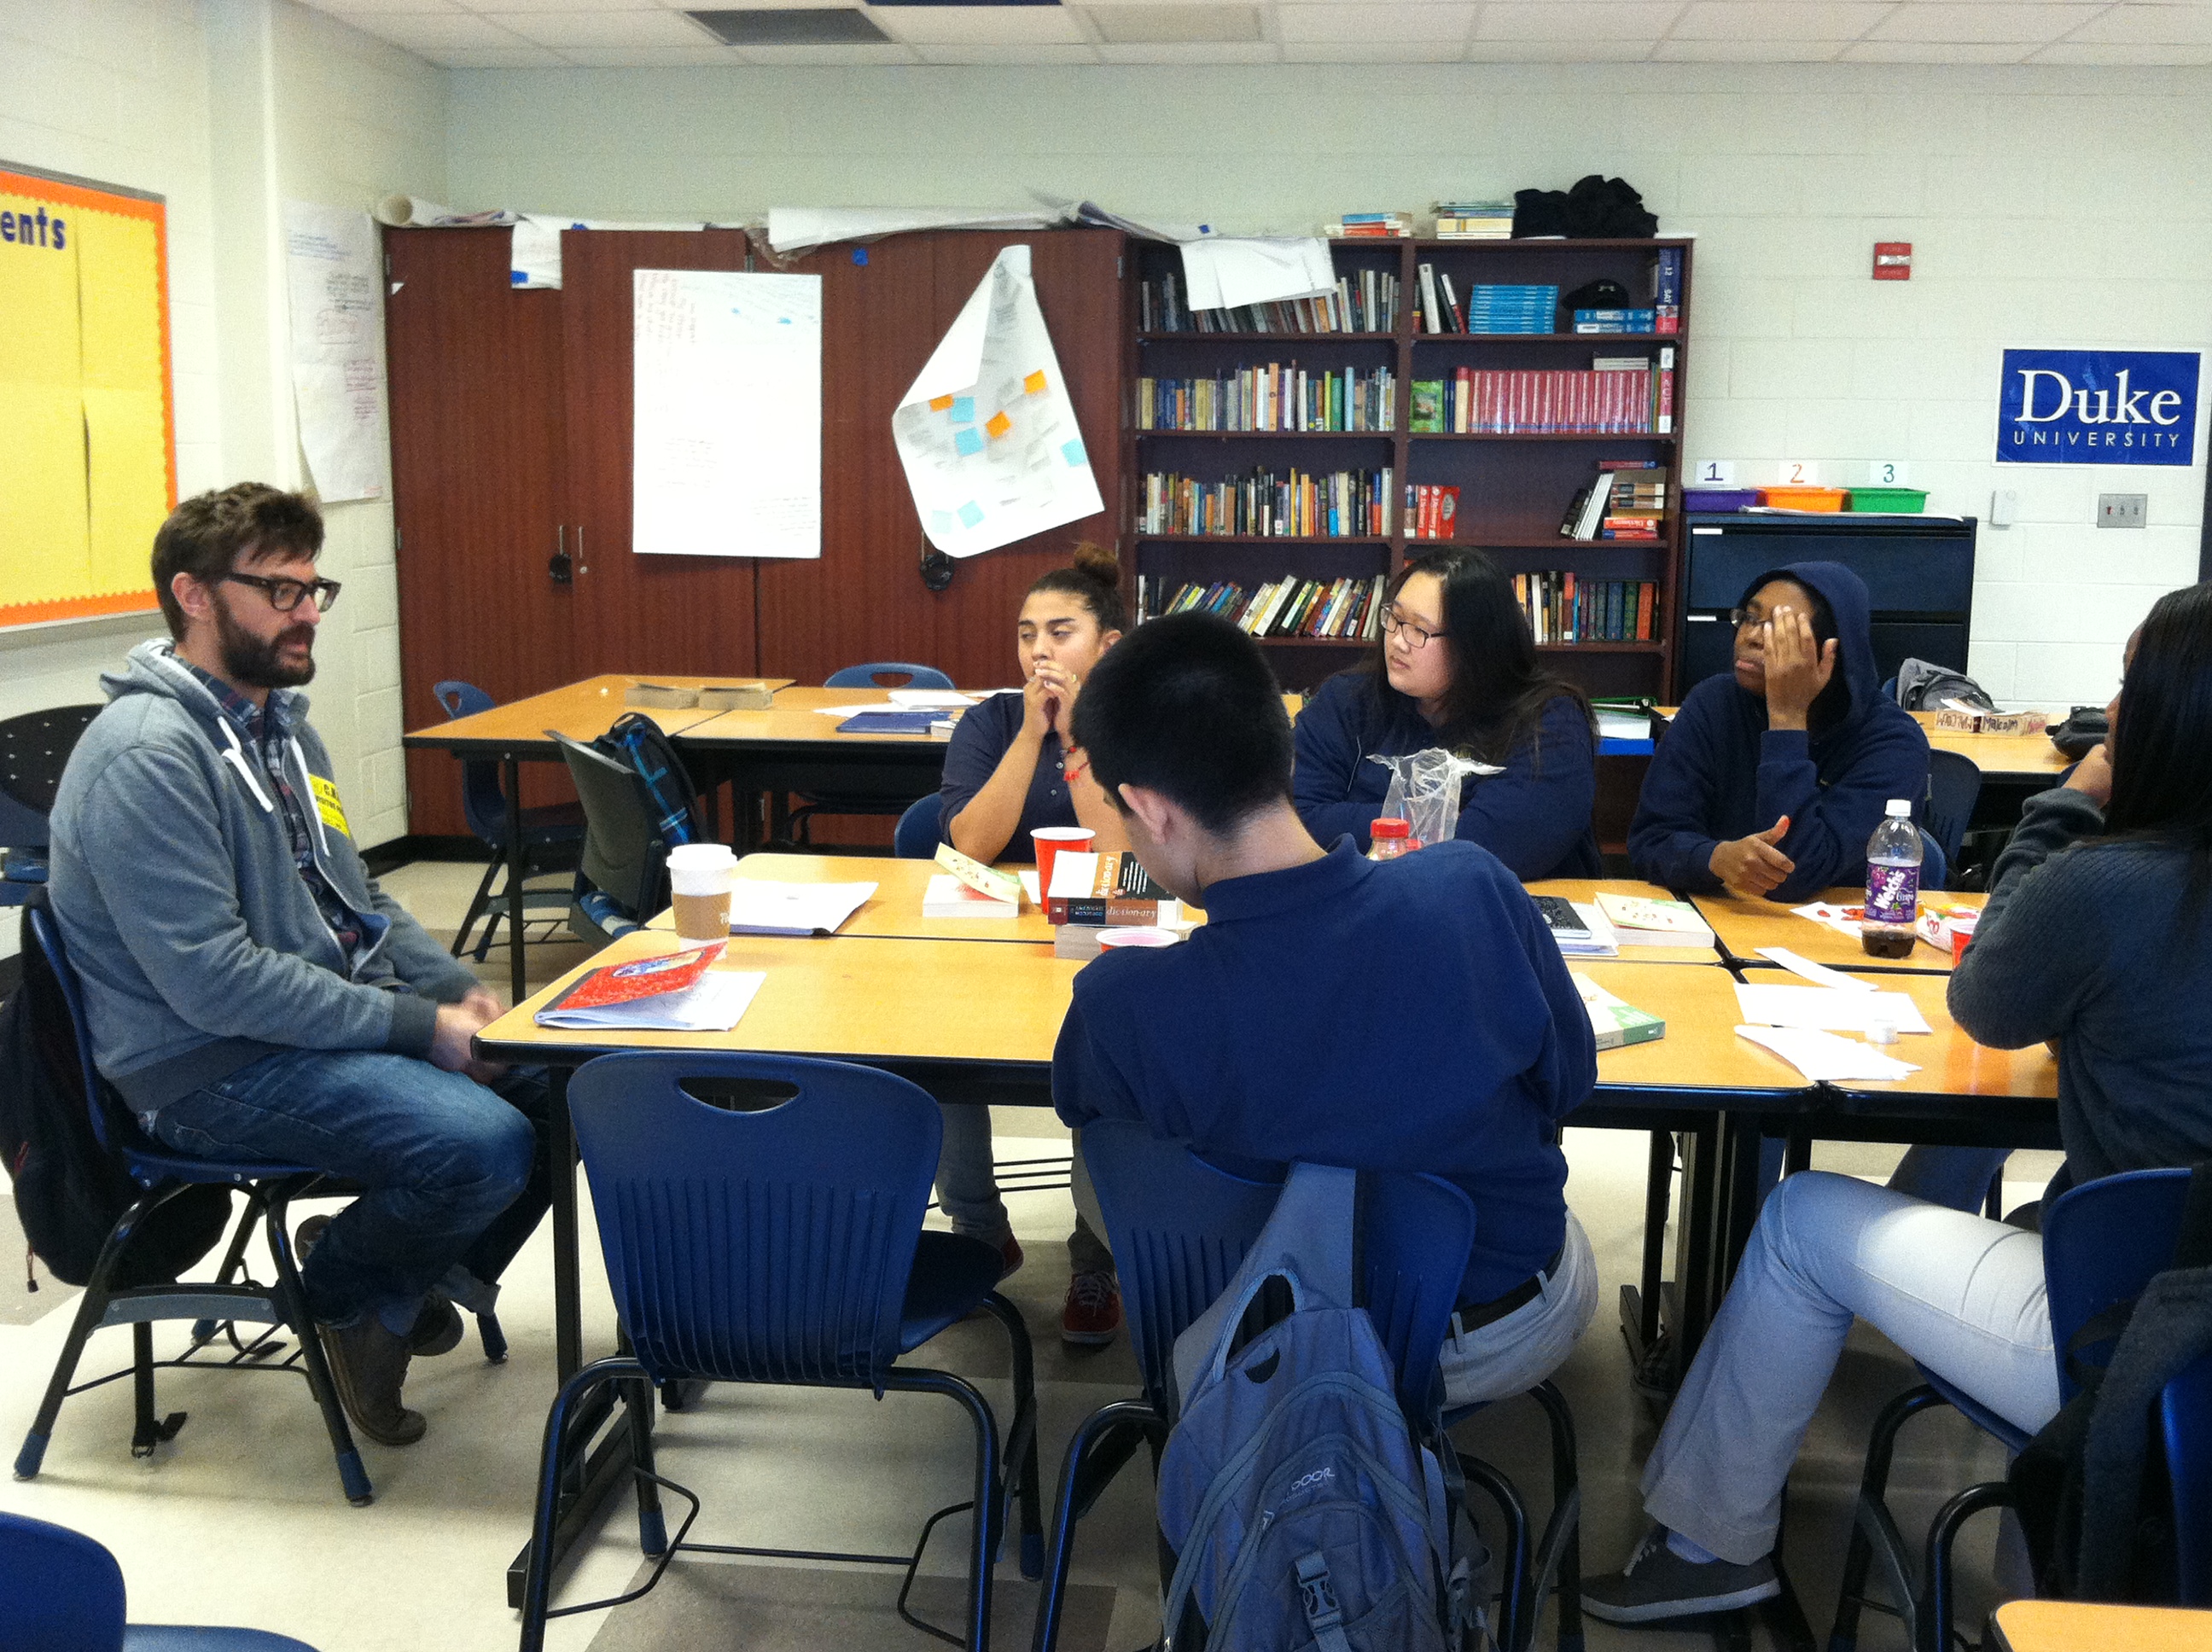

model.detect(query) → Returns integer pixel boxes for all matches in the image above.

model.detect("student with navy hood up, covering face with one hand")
[1628,561,1929,900]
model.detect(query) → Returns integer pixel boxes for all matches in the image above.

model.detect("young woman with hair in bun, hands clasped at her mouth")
[938,542,1128,1345]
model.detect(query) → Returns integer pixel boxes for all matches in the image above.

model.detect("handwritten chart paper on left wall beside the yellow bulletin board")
[283,201,392,504]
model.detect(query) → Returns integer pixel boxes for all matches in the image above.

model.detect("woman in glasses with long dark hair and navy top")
[1292,546,1602,880]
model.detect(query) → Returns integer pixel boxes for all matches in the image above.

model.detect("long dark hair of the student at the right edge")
[2104,584,2212,913]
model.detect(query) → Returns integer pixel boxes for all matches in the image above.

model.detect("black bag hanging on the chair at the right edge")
[2006,1163,2212,1606]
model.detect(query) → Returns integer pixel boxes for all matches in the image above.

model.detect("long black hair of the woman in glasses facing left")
[1363,546,1595,765]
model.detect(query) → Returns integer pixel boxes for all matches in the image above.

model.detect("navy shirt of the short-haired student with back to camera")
[1053,838,1597,1303]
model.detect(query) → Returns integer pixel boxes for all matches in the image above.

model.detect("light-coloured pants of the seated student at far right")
[1644,1170,2059,1566]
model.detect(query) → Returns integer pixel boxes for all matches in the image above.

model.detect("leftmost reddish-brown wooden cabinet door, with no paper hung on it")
[385,228,579,836]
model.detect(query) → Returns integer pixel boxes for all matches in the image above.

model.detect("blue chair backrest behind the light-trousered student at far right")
[2044,1170,2190,1402]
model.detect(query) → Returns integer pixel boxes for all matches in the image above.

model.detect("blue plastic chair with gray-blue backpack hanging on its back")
[1031,1121,1557,1652]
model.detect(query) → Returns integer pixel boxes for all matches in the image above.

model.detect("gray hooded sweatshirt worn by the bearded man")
[49,639,475,1114]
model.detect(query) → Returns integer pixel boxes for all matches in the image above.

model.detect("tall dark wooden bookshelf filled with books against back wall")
[1121,239,1692,699]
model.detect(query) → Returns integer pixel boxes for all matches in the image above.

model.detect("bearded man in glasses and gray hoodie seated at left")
[49,482,550,1446]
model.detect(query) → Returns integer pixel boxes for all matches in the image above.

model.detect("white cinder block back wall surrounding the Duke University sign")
[449,61,2212,706]
